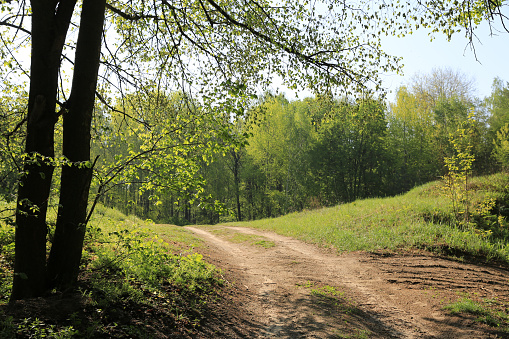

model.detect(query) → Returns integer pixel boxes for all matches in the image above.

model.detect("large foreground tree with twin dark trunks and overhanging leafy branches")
[0,0,398,300]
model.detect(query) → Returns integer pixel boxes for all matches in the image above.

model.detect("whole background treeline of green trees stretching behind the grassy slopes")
[0,69,509,224]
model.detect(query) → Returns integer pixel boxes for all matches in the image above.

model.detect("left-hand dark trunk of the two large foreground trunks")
[11,0,76,300]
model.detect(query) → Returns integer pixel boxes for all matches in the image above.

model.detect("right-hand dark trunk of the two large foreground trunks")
[48,0,106,289]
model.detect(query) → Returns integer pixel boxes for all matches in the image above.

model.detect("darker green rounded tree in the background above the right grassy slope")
[309,98,387,205]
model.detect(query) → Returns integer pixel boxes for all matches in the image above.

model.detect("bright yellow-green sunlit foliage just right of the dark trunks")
[92,92,232,222]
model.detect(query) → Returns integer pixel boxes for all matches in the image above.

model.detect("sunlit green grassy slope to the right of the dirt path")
[228,174,509,263]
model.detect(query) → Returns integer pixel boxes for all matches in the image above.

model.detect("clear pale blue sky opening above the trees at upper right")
[382,20,509,98]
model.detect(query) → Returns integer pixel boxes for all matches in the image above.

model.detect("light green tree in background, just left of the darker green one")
[242,94,314,216]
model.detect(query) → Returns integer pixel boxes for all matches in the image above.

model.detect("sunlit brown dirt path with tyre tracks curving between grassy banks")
[188,226,509,338]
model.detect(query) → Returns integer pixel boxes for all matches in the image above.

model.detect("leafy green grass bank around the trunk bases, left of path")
[0,202,223,338]
